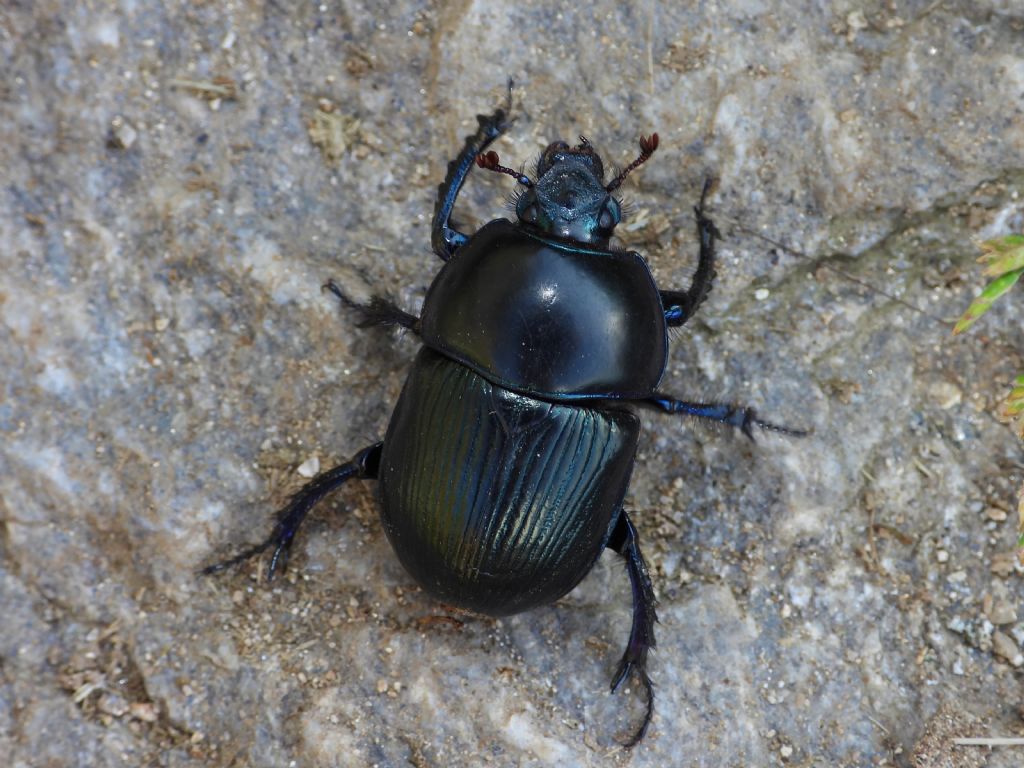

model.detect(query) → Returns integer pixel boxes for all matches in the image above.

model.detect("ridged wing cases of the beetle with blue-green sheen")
[378,349,640,615]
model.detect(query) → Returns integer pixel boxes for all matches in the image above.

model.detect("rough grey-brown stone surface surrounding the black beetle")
[0,0,1024,767]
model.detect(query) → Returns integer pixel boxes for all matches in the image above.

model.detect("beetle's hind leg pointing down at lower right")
[608,510,657,746]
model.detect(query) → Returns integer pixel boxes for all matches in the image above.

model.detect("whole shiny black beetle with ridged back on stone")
[204,88,803,746]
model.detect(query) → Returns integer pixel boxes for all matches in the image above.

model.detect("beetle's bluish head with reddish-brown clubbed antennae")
[476,133,657,247]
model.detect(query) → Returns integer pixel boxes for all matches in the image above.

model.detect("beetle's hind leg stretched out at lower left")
[200,442,384,581]
